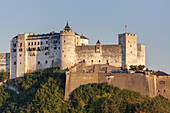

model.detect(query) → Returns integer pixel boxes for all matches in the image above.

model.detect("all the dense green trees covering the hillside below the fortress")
[0,68,170,113]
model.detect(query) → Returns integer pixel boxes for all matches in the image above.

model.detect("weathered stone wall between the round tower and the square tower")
[75,45,122,67]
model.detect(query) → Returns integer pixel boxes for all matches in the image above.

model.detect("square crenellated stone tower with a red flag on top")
[118,33,138,69]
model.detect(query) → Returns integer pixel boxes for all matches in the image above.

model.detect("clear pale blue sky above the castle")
[0,0,170,73]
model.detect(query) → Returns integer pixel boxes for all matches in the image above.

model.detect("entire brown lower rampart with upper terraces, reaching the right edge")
[65,62,170,100]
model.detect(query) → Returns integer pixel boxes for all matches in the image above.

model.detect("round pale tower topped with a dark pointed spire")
[60,22,75,69]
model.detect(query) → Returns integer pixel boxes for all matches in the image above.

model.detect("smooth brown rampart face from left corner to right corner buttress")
[65,72,157,99]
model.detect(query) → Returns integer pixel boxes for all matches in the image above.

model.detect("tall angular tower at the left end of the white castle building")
[10,33,28,79]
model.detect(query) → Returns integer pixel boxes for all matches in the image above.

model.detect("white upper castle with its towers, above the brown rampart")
[10,23,145,79]
